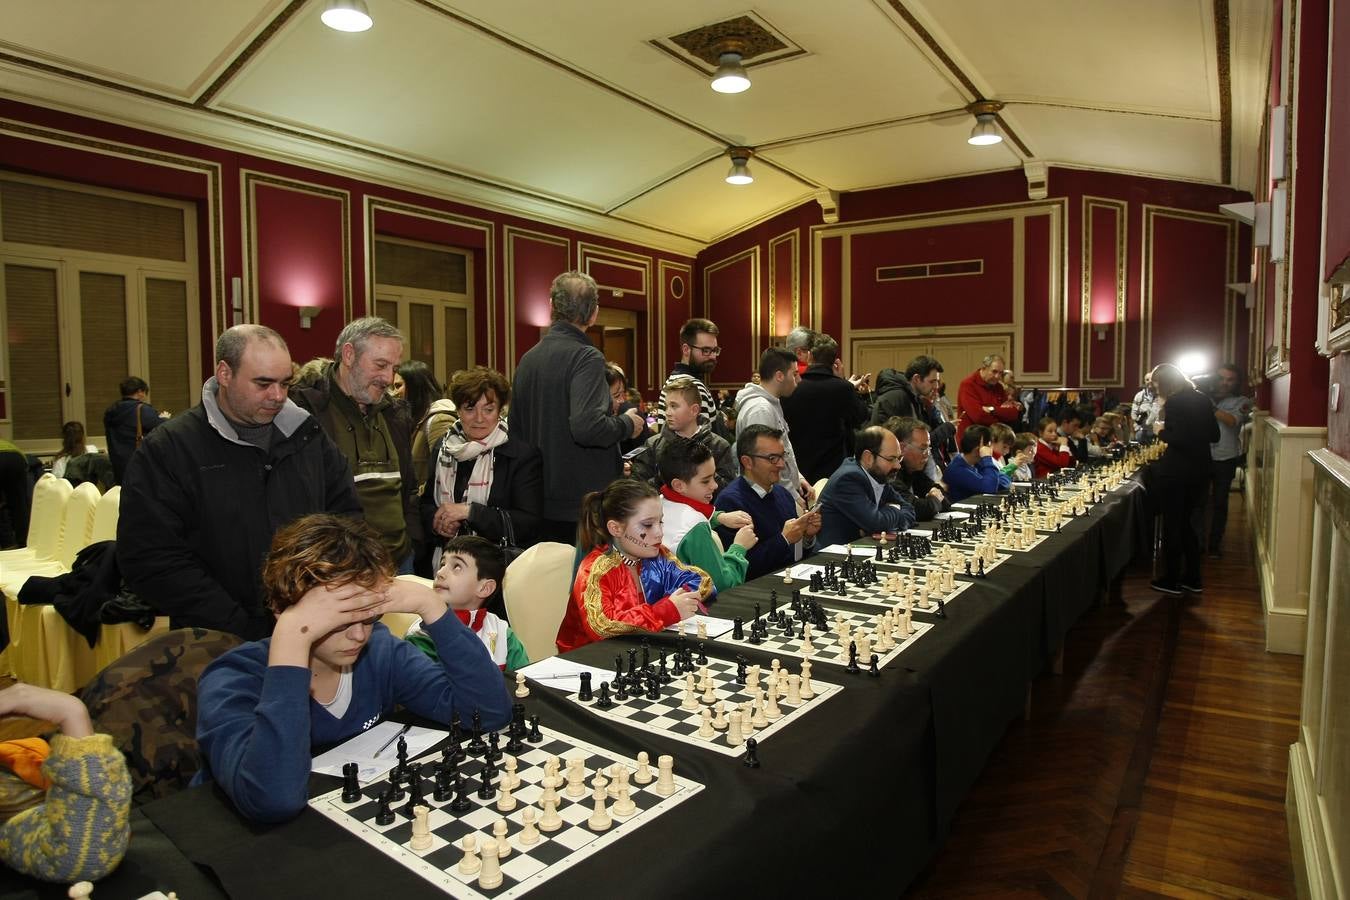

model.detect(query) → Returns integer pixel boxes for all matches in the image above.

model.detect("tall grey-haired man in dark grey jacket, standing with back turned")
[509,271,647,544]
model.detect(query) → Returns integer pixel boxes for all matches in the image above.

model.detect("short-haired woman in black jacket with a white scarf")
[421,366,544,571]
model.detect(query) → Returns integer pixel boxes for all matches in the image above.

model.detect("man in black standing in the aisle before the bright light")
[1149,363,1219,595]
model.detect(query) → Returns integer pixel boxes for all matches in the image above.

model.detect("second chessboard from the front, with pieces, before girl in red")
[556,637,844,756]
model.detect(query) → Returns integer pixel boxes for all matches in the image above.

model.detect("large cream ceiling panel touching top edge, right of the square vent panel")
[906,0,1218,117]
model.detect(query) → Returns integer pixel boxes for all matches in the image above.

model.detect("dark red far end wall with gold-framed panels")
[695,167,1250,394]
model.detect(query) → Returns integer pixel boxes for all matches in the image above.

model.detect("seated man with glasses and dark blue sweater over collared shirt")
[713,425,821,580]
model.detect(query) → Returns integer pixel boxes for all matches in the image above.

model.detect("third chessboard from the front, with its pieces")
[713,591,937,668]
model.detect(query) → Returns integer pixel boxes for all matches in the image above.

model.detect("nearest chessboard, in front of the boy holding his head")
[309,723,703,900]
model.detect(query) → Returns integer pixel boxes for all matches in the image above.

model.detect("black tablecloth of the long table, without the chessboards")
[0,480,1146,900]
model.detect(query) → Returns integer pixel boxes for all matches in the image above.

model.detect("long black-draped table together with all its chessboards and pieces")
[63,459,1146,900]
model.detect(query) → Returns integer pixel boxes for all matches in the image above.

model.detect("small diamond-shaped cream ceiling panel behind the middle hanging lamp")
[614,157,810,242]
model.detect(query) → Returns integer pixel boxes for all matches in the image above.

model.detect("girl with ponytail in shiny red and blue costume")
[558,478,714,653]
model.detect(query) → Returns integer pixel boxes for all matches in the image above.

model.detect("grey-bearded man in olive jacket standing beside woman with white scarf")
[296,316,423,575]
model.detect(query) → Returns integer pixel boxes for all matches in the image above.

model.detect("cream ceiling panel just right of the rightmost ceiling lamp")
[1015,107,1222,182]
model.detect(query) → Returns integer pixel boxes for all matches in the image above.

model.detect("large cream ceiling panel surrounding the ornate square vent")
[440,0,967,144]
